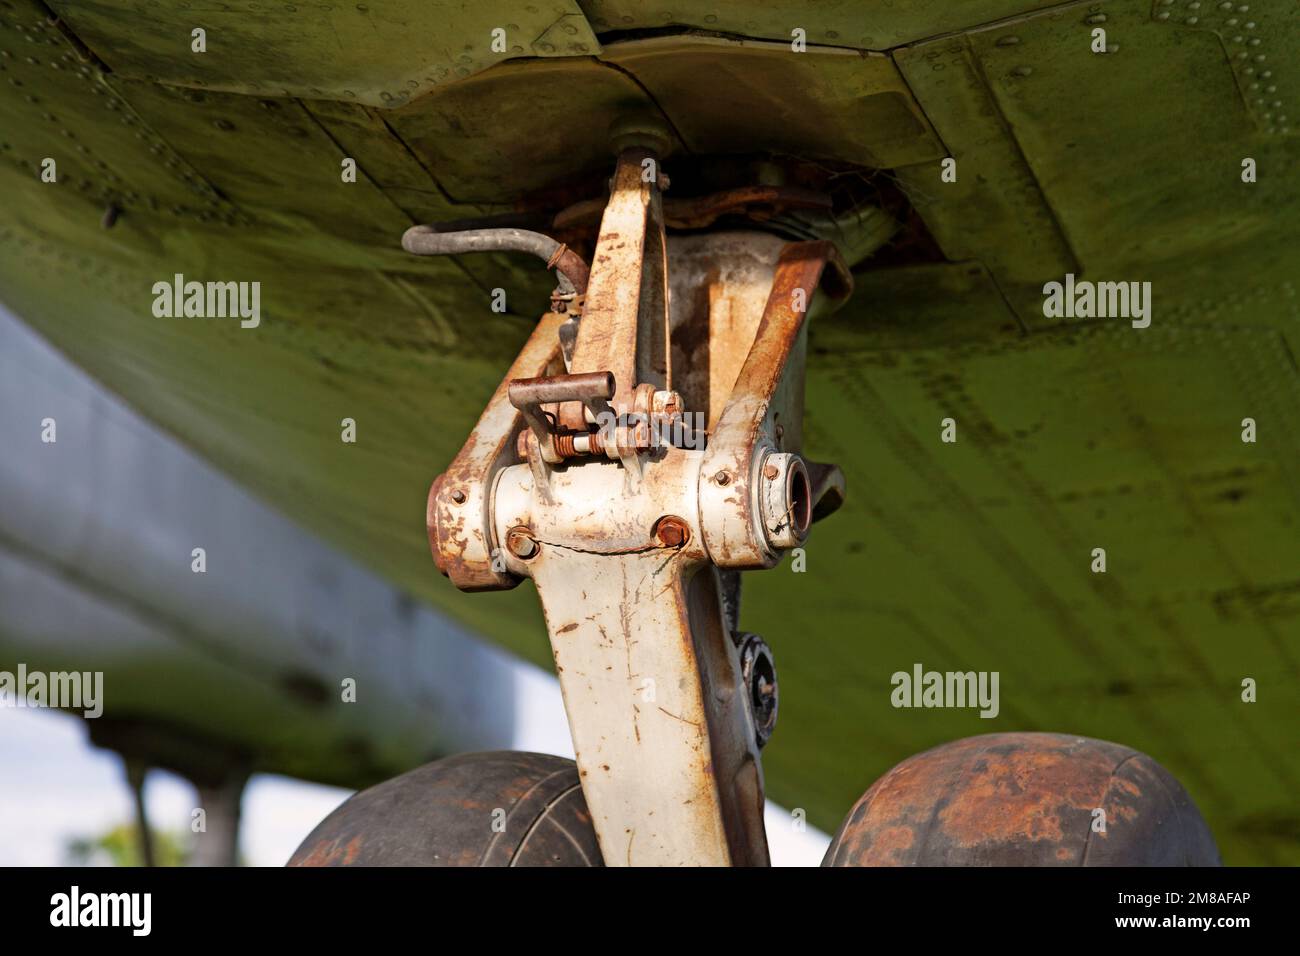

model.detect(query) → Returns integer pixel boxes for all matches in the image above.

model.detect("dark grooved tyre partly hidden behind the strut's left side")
[289,750,605,866]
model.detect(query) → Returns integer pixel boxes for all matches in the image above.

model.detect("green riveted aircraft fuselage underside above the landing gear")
[0,0,1300,864]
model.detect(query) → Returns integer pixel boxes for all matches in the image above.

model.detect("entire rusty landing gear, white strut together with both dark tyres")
[294,130,1213,866]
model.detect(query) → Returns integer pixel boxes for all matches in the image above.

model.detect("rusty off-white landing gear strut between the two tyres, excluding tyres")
[416,144,850,865]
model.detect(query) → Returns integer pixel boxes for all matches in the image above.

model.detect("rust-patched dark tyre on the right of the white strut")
[822,734,1221,866]
